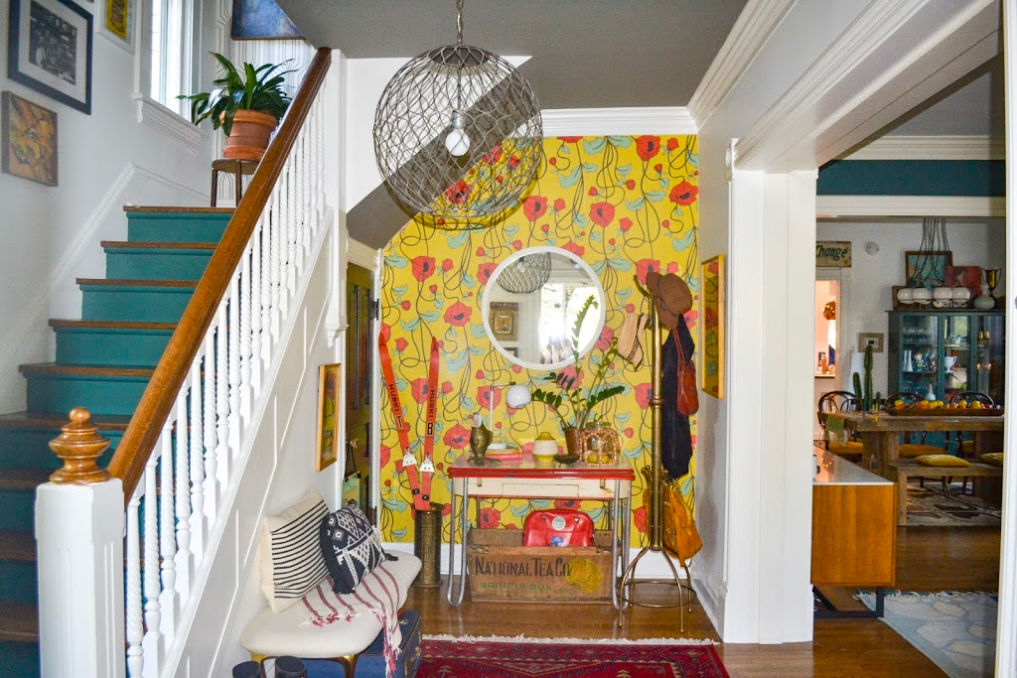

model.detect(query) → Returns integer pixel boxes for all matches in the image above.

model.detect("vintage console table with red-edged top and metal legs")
[446,454,636,609]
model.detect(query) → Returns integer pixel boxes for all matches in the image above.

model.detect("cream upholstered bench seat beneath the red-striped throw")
[240,552,420,659]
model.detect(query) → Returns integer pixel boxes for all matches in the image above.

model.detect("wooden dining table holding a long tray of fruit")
[827,410,1003,478]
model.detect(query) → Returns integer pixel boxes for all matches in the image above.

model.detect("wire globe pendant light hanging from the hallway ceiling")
[374,0,543,222]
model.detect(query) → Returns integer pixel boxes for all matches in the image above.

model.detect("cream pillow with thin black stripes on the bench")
[261,490,328,612]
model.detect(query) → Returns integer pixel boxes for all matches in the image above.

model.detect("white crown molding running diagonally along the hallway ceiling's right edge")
[689,0,794,129]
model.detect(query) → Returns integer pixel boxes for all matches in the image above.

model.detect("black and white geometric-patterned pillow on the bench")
[318,501,395,594]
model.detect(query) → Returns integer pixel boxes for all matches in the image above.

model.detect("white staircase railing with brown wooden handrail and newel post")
[37,50,331,678]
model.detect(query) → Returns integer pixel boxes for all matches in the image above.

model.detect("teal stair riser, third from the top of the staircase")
[79,285,194,322]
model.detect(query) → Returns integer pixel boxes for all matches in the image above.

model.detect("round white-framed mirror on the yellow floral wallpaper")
[481,247,605,370]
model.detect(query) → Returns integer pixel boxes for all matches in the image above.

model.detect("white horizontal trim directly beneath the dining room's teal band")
[816,195,1007,219]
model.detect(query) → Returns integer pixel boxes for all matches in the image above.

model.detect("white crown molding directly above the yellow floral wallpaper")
[540,106,699,137]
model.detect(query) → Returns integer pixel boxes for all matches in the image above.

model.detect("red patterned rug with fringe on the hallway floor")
[417,637,727,678]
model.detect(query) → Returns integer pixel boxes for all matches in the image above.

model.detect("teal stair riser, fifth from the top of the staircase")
[28,374,148,415]
